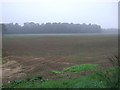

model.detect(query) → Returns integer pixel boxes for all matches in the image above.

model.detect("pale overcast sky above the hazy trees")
[0,0,118,28]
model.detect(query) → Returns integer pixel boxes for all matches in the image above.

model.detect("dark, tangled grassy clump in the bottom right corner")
[96,67,120,88]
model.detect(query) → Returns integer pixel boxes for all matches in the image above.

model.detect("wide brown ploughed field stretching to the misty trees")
[3,34,118,83]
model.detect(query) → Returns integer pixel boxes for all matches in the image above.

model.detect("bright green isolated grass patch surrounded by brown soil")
[63,64,99,73]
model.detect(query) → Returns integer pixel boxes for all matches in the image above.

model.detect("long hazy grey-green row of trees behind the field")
[1,22,102,34]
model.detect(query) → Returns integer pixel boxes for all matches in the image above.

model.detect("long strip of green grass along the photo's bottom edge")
[1,74,109,88]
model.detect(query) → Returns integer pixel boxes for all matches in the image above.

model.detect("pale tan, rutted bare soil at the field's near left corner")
[2,56,74,83]
